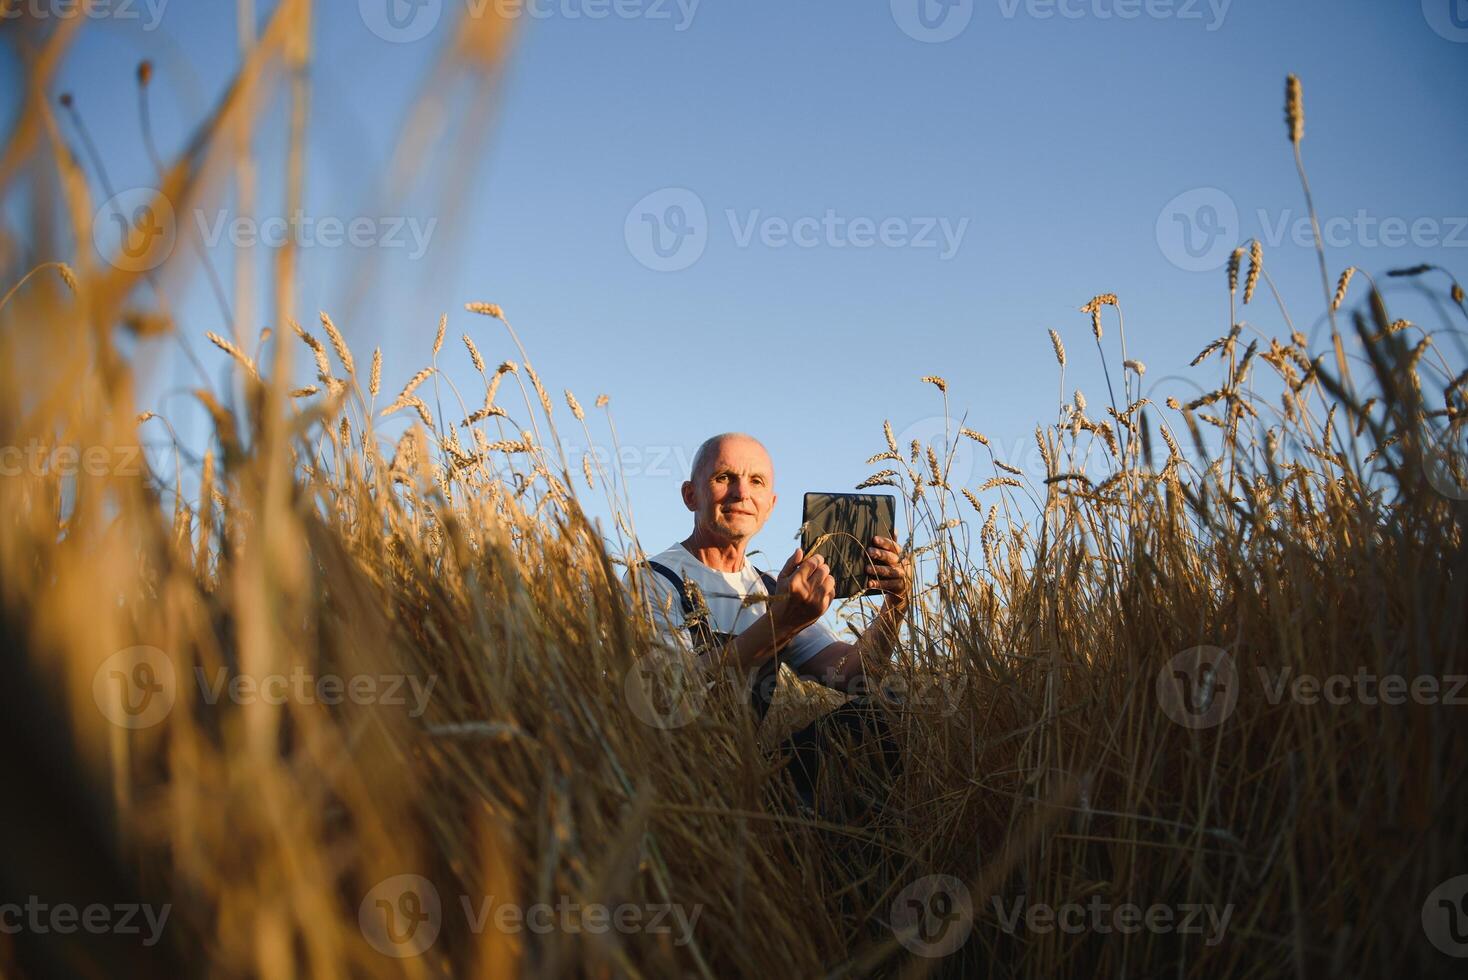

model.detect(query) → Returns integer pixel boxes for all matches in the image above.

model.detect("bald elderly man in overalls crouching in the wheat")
[628,433,910,804]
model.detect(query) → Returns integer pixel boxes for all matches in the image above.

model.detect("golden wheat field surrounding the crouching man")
[0,17,1468,977]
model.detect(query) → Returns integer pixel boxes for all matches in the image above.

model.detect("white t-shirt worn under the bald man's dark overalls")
[622,544,840,668]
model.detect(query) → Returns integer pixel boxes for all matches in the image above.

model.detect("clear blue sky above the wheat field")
[0,0,1468,565]
